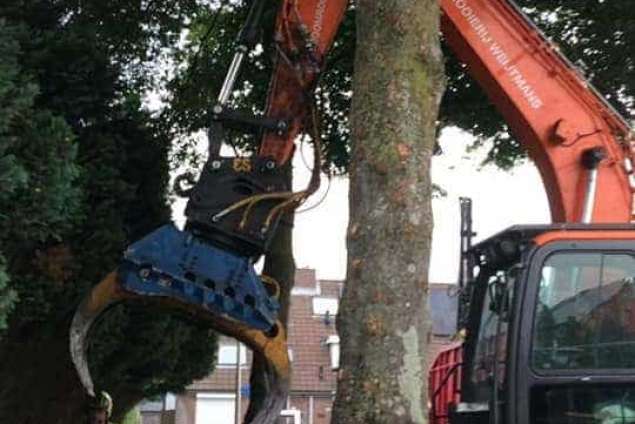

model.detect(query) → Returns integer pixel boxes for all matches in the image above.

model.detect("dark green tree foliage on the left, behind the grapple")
[0,0,216,414]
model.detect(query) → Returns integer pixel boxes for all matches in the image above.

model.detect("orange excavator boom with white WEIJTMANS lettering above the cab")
[441,0,635,223]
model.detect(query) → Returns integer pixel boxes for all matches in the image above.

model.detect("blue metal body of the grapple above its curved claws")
[118,225,279,331]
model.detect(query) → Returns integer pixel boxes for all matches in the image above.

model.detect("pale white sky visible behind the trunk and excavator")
[173,128,549,283]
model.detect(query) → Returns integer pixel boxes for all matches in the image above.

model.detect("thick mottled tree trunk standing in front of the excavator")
[333,0,443,424]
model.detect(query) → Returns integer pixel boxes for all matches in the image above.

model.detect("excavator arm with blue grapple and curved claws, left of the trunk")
[70,0,347,423]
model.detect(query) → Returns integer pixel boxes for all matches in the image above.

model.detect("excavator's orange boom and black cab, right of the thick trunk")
[428,0,635,424]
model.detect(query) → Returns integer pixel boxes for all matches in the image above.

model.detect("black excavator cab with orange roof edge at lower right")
[450,224,635,424]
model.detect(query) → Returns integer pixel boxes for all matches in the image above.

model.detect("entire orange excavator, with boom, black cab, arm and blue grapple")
[70,0,635,424]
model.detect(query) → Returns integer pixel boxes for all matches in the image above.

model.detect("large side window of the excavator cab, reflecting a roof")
[532,252,635,370]
